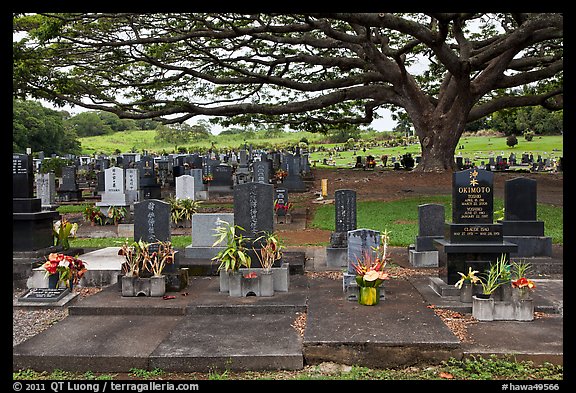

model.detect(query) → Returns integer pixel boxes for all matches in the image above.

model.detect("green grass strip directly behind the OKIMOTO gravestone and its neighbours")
[311,195,563,247]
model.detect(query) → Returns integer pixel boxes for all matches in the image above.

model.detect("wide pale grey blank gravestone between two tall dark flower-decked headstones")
[184,213,234,260]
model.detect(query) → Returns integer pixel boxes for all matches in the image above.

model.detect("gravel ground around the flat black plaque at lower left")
[12,287,101,346]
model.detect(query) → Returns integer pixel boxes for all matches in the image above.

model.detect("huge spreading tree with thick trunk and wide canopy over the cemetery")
[13,13,563,171]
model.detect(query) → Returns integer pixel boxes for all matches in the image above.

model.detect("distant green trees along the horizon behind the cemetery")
[12,99,563,156]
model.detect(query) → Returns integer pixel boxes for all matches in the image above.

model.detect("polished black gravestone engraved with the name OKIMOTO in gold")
[434,169,518,285]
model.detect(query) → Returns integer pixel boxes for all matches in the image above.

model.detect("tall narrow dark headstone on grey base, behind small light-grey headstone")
[326,190,356,267]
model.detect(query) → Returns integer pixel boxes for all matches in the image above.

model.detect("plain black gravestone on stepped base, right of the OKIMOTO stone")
[501,177,552,257]
